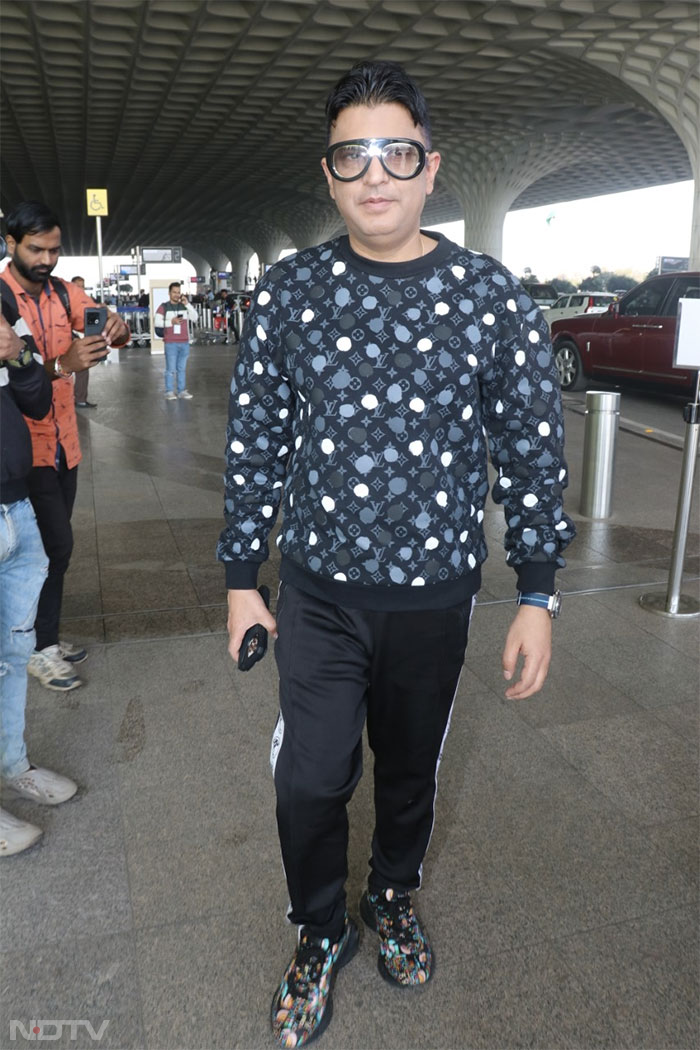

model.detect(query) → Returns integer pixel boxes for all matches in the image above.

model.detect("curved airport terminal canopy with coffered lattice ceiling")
[1,0,700,272]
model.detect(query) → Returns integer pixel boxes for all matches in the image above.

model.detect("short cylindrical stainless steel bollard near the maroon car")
[580,391,620,518]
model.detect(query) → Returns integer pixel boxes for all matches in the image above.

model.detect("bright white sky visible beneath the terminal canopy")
[50,182,693,288]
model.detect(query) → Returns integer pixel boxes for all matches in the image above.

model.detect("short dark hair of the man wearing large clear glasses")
[325,62,430,146]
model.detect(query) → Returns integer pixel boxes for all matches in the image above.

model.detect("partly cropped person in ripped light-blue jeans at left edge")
[0,308,78,857]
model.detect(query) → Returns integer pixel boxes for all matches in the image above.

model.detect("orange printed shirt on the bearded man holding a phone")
[1,267,114,467]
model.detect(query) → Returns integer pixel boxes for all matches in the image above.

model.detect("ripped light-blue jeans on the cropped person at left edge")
[0,500,48,777]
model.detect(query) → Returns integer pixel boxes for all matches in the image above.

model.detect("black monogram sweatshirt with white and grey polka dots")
[217,234,574,610]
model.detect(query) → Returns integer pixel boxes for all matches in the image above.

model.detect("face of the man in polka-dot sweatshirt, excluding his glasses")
[321,102,440,256]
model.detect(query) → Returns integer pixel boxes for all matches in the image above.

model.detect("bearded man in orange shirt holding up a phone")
[0,201,129,692]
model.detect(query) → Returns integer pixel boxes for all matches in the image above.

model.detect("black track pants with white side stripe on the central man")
[271,584,472,939]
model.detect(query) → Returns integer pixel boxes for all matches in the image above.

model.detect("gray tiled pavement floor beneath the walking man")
[0,347,700,1050]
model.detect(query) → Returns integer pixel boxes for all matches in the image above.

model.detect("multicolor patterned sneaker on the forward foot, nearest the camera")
[272,916,360,1047]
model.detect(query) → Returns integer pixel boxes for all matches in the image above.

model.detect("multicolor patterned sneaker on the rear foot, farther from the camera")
[360,889,432,988]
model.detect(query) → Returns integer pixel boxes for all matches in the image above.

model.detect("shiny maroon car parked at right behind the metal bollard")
[552,272,700,391]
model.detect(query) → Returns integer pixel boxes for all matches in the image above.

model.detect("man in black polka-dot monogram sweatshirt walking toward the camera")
[218,62,574,1047]
